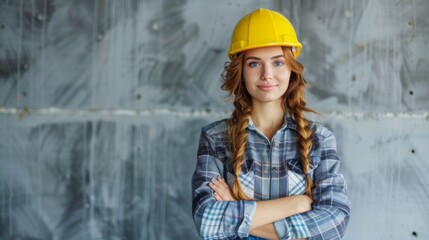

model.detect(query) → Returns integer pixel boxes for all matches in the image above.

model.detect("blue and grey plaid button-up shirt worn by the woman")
[192,116,350,239]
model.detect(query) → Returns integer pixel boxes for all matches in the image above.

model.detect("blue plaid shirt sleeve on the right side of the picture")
[274,129,350,240]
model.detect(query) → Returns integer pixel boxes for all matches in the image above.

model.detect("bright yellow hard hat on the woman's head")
[228,8,302,60]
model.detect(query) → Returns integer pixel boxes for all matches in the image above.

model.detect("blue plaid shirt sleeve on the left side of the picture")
[192,131,256,239]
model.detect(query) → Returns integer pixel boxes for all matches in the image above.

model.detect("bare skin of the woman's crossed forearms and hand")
[209,177,312,239]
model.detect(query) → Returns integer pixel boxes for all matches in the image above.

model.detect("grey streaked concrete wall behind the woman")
[0,0,429,240]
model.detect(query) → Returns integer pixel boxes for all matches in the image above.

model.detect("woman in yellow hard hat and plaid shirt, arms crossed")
[192,9,350,239]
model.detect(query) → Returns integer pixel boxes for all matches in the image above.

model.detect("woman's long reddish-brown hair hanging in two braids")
[221,47,314,200]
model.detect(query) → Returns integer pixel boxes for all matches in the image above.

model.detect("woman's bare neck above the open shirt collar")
[251,101,285,139]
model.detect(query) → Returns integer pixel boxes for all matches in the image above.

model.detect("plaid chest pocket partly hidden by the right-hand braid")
[287,156,320,196]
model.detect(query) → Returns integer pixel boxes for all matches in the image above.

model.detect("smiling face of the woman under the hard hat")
[243,47,291,104]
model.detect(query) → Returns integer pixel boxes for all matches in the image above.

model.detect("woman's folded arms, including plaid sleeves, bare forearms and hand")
[192,130,350,240]
